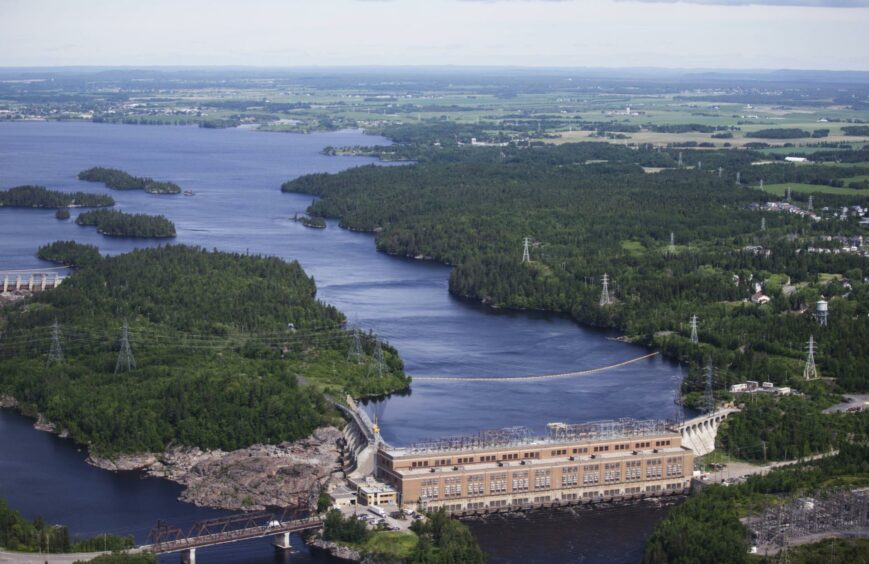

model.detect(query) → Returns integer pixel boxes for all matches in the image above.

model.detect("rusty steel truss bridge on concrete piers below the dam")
[136,508,323,564]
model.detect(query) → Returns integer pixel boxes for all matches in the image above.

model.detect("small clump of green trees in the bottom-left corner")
[0,499,133,553]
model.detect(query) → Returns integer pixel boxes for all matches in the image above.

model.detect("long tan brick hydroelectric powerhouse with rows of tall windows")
[375,419,694,513]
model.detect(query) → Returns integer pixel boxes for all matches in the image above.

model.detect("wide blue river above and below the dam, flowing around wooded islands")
[0,122,682,562]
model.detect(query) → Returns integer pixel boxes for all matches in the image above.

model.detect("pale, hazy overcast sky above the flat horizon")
[0,0,869,70]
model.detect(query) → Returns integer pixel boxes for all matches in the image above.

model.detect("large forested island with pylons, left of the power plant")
[0,242,408,454]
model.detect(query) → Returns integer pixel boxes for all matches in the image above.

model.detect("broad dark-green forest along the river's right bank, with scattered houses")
[283,143,869,459]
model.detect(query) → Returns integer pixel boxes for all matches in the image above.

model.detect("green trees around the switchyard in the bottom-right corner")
[643,445,869,564]
